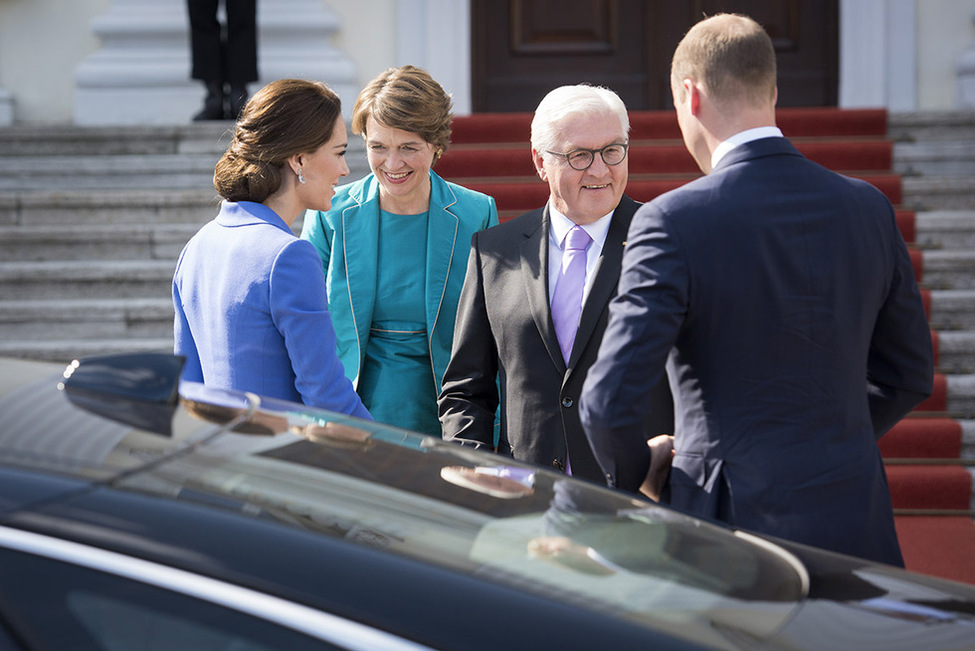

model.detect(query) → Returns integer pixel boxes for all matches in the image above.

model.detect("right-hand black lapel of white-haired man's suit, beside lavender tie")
[569,195,639,368]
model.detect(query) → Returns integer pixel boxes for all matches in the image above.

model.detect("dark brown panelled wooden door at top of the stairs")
[471,0,839,112]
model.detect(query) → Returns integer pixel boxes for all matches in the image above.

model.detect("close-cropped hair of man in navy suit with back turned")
[670,14,776,105]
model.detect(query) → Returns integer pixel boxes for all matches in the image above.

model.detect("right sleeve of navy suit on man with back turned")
[867,209,934,438]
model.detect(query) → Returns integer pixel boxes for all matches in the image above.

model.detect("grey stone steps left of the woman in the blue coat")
[0,122,368,363]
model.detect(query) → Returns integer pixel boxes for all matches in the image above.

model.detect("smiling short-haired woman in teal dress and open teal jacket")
[302,66,498,436]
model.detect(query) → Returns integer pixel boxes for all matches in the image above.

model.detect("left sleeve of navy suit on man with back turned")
[579,204,689,492]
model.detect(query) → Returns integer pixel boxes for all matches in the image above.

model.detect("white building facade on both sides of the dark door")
[0,0,975,125]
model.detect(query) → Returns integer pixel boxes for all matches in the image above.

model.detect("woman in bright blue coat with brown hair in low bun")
[173,79,370,418]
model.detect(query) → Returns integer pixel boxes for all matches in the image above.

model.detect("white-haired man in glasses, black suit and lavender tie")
[439,85,673,482]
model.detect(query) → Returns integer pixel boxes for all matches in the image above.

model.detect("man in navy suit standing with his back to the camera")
[582,14,933,565]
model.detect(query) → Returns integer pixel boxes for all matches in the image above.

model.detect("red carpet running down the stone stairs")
[436,108,975,583]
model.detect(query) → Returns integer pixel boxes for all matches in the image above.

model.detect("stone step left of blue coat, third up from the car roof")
[0,258,176,301]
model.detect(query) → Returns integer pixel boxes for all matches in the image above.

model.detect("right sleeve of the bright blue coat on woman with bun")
[270,239,372,420]
